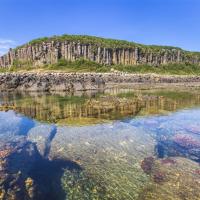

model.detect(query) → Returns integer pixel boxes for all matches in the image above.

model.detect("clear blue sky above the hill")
[0,0,200,54]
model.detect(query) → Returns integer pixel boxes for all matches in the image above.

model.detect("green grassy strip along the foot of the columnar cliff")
[0,59,200,75]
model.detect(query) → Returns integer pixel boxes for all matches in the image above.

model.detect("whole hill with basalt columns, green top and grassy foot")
[0,35,200,75]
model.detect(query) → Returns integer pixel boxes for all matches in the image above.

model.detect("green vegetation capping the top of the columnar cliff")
[12,34,200,58]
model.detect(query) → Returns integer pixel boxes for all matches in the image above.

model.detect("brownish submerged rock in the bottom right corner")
[138,157,200,200]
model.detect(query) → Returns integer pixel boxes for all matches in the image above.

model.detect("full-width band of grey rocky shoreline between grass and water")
[0,72,200,92]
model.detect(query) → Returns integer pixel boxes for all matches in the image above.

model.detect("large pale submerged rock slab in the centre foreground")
[49,122,155,200]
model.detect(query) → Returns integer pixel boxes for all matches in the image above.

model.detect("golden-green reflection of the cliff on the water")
[0,89,200,125]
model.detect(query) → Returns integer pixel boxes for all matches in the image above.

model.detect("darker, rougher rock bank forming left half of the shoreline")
[0,73,105,92]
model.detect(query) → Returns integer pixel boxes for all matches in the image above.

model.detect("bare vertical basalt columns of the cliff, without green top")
[0,41,200,67]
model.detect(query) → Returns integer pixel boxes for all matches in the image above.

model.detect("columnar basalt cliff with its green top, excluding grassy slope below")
[0,35,200,68]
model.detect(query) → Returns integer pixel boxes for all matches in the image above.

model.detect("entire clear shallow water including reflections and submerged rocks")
[0,88,200,200]
